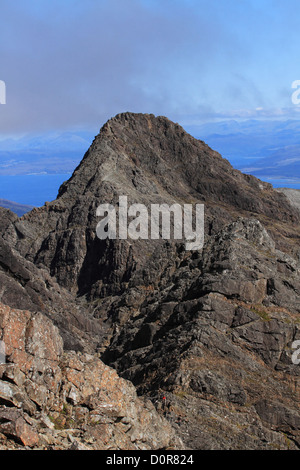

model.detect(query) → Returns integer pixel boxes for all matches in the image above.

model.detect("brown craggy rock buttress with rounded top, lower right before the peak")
[104,219,300,449]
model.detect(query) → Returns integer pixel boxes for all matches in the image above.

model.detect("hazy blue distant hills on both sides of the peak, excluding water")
[0,120,300,183]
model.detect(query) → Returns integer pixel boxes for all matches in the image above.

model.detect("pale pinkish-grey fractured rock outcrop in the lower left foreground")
[0,304,181,450]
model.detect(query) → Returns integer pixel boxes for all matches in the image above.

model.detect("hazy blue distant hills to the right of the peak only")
[187,120,300,188]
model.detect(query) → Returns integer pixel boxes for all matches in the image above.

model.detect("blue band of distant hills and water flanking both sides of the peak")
[0,120,300,212]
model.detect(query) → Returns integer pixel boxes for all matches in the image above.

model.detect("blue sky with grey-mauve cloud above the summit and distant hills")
[0,0,300,138]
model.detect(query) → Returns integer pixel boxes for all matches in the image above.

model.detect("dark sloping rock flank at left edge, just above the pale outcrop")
[0,208,101,350]
